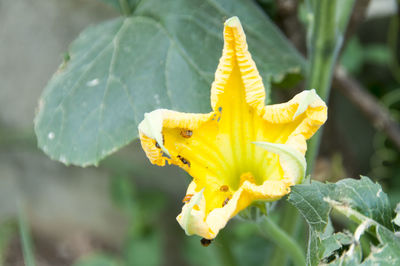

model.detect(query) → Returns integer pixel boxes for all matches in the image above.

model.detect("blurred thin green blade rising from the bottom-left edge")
[18,205,35,266]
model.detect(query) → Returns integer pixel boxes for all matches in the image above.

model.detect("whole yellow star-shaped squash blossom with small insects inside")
[139,17,327,239]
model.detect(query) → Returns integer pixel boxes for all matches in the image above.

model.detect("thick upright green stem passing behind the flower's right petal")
[306,0,354,174]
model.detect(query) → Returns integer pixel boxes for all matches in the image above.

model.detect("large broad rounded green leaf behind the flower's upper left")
[35,0,304,166]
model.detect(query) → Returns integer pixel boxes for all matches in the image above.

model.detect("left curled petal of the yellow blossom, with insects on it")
[139,109,226,186]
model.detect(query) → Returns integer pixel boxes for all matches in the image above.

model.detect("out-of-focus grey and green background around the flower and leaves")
[0,0,400,266]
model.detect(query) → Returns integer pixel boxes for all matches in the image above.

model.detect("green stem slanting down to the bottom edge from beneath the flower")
[260,216,306,266]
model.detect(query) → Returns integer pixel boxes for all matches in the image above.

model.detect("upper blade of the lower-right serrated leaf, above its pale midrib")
[289,176,393,235]
